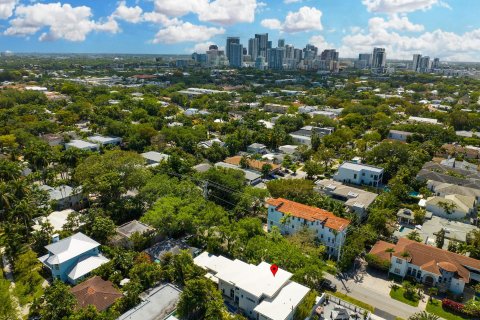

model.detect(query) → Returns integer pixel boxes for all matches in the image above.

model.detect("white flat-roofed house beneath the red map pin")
[193,252,313,320]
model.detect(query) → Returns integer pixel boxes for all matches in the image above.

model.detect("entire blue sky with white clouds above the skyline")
[0,0,480,61]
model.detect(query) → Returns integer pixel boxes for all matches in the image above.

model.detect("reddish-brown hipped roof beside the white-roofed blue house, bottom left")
[70,276,122,311]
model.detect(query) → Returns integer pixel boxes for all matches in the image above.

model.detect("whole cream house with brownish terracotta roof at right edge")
[370,238,480,294]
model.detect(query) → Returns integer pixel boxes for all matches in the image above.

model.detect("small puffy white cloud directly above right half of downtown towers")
[261,6,323,33]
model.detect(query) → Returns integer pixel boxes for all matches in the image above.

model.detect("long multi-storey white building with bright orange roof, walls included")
[267,198,350,259]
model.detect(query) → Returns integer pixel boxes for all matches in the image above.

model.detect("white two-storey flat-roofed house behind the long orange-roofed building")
[333,161,384,187]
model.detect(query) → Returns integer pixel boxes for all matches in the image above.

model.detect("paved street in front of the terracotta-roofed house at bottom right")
[325,274,421,319]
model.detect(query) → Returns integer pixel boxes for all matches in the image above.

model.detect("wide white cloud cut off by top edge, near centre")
[154,0,264,25]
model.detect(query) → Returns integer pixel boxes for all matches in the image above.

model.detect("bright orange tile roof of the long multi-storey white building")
[267,198,350,231]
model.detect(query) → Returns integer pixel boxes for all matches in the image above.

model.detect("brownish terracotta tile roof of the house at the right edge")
[370,238,480,283]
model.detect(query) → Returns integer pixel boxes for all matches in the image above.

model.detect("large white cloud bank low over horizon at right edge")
[339,17,480,61]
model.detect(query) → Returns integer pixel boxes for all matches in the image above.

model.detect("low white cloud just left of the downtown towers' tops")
[152,22,225,44]
